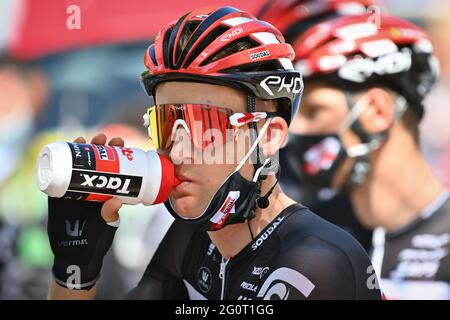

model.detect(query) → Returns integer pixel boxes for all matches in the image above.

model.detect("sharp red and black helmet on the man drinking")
[141,7,303,124]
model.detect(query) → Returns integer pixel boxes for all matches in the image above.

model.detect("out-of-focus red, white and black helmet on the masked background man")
[293,14,439,117]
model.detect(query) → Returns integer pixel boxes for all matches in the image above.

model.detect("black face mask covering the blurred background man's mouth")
[281,134,347,189]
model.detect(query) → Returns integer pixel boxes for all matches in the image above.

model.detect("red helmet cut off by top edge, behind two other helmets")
[257,0,374,43]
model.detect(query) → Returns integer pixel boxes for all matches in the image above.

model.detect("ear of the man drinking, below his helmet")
[262,117,288,158]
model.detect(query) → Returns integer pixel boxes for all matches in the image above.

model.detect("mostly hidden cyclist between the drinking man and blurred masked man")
[258,0,378,250]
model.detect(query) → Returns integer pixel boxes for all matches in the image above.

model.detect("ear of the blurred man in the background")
[359,88,395,134]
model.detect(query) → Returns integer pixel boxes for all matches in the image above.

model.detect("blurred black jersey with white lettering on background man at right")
[372,192,450,299]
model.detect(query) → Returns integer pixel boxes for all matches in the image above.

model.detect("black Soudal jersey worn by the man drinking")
[127,204,381,300]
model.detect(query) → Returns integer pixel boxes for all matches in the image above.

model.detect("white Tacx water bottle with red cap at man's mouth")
[37,142,179,205]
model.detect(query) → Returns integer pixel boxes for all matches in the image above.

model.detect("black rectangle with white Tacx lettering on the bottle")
[69,170,142,197]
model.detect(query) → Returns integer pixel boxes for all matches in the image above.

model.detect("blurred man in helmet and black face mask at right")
[286,14,450,299]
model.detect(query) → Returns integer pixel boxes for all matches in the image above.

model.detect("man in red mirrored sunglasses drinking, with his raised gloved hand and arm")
[48,7,381,299]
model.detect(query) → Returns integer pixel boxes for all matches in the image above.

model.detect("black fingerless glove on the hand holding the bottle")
[47,197,119,290]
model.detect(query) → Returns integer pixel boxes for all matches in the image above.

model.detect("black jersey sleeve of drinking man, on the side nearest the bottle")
[125,221,195,300]
